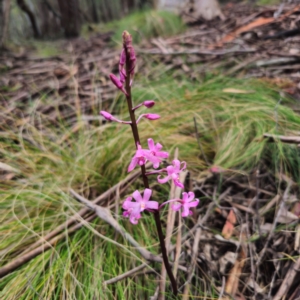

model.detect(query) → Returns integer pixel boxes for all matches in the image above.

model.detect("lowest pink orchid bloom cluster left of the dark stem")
[122,189,159,224]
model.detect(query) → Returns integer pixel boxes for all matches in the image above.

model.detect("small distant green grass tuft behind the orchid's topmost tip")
[107,10,185,44]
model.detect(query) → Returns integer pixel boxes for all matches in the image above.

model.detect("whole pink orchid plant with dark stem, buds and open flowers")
[100,31,199,296]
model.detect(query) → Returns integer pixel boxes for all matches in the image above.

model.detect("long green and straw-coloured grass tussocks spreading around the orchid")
[0,73,300,300]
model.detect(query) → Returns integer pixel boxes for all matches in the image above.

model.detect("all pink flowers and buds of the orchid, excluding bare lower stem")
[100,31,199,224]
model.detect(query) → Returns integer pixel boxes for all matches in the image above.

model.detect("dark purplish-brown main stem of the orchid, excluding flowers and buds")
[124,41,178,296]
